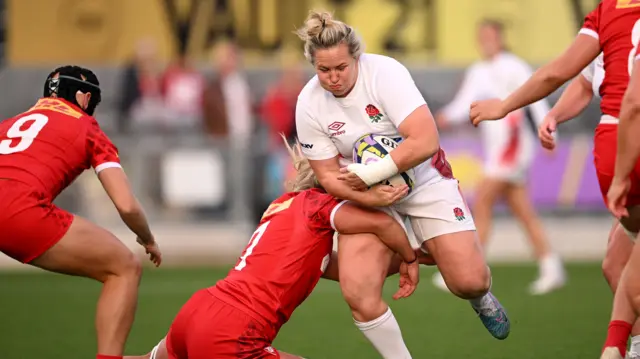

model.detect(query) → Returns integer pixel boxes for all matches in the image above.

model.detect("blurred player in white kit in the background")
[433,20,566,295]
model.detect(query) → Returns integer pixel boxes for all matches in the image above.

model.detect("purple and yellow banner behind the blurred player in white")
[440,135,606,212]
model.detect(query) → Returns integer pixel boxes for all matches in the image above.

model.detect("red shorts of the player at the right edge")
[593,124,640,206]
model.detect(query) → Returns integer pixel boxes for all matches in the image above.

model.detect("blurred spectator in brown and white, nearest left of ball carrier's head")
[203,42,254,144]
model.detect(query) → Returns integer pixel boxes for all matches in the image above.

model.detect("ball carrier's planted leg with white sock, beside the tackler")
[338,234,411,359]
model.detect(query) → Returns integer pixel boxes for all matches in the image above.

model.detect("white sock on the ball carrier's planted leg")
[354,308,411,359]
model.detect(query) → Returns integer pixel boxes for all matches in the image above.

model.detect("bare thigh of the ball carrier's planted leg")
[338,233,393,296]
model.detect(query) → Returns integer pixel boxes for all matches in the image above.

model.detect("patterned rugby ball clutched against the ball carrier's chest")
[353,134,416,193]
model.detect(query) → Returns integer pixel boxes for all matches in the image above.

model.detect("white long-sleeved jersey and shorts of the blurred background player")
[443,52,549,173]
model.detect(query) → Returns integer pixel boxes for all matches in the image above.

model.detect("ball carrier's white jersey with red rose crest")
[296,54,442,185]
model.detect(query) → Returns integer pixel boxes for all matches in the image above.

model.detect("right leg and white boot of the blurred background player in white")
[504,182,566,295]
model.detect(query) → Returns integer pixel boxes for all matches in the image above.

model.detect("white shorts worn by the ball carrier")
[387,179,476,245]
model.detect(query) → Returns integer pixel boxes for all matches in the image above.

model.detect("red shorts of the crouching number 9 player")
[0,179,73,263]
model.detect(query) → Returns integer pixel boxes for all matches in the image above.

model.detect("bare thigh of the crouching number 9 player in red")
[30,212,141,281]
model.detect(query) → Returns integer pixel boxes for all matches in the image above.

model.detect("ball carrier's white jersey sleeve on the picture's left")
[296,100,338,161]
